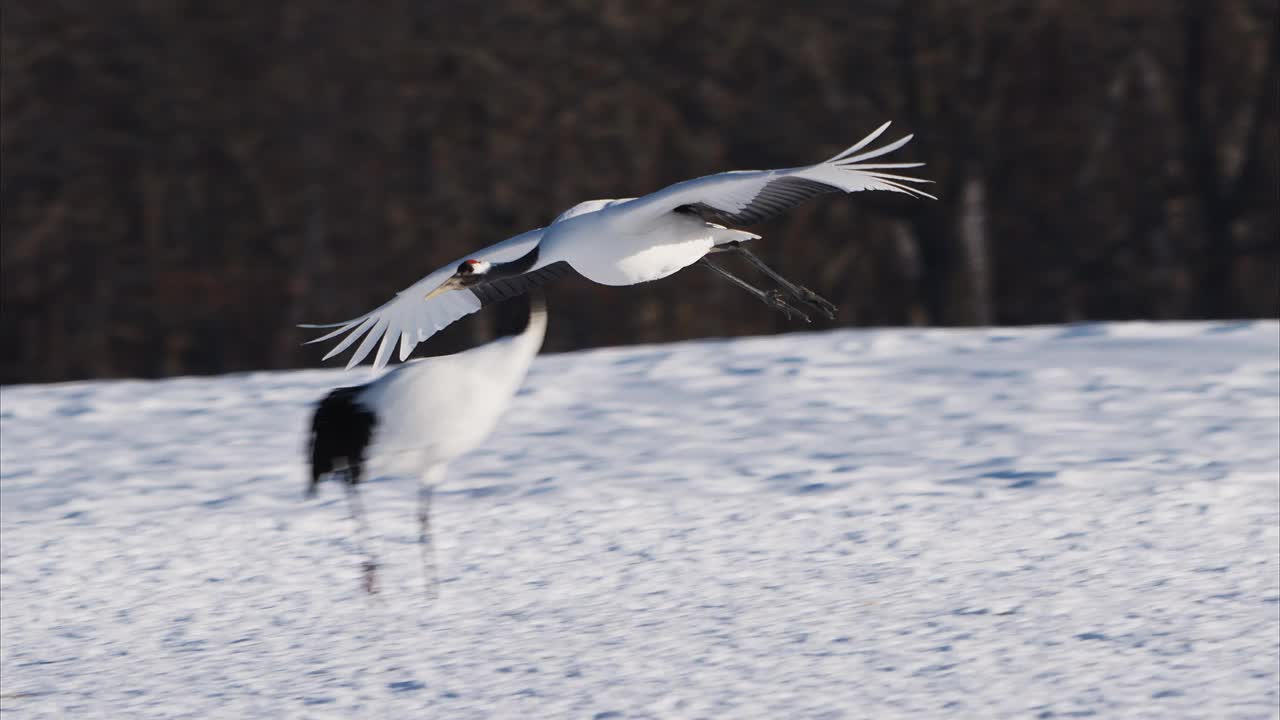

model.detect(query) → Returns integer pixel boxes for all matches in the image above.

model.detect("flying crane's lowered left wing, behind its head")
[298,228,555,370]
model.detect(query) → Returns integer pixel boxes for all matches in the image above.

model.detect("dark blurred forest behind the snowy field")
[0,0,1280,383]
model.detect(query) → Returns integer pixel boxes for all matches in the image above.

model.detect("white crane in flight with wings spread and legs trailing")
[302,123,933,369]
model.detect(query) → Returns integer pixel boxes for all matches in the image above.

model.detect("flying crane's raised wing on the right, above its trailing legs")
[609,123,936,227]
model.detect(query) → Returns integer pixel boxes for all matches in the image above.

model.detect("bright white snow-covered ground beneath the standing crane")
[0,322,1280,719]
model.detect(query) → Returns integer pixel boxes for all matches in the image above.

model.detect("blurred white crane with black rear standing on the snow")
[307,290,547,592]
